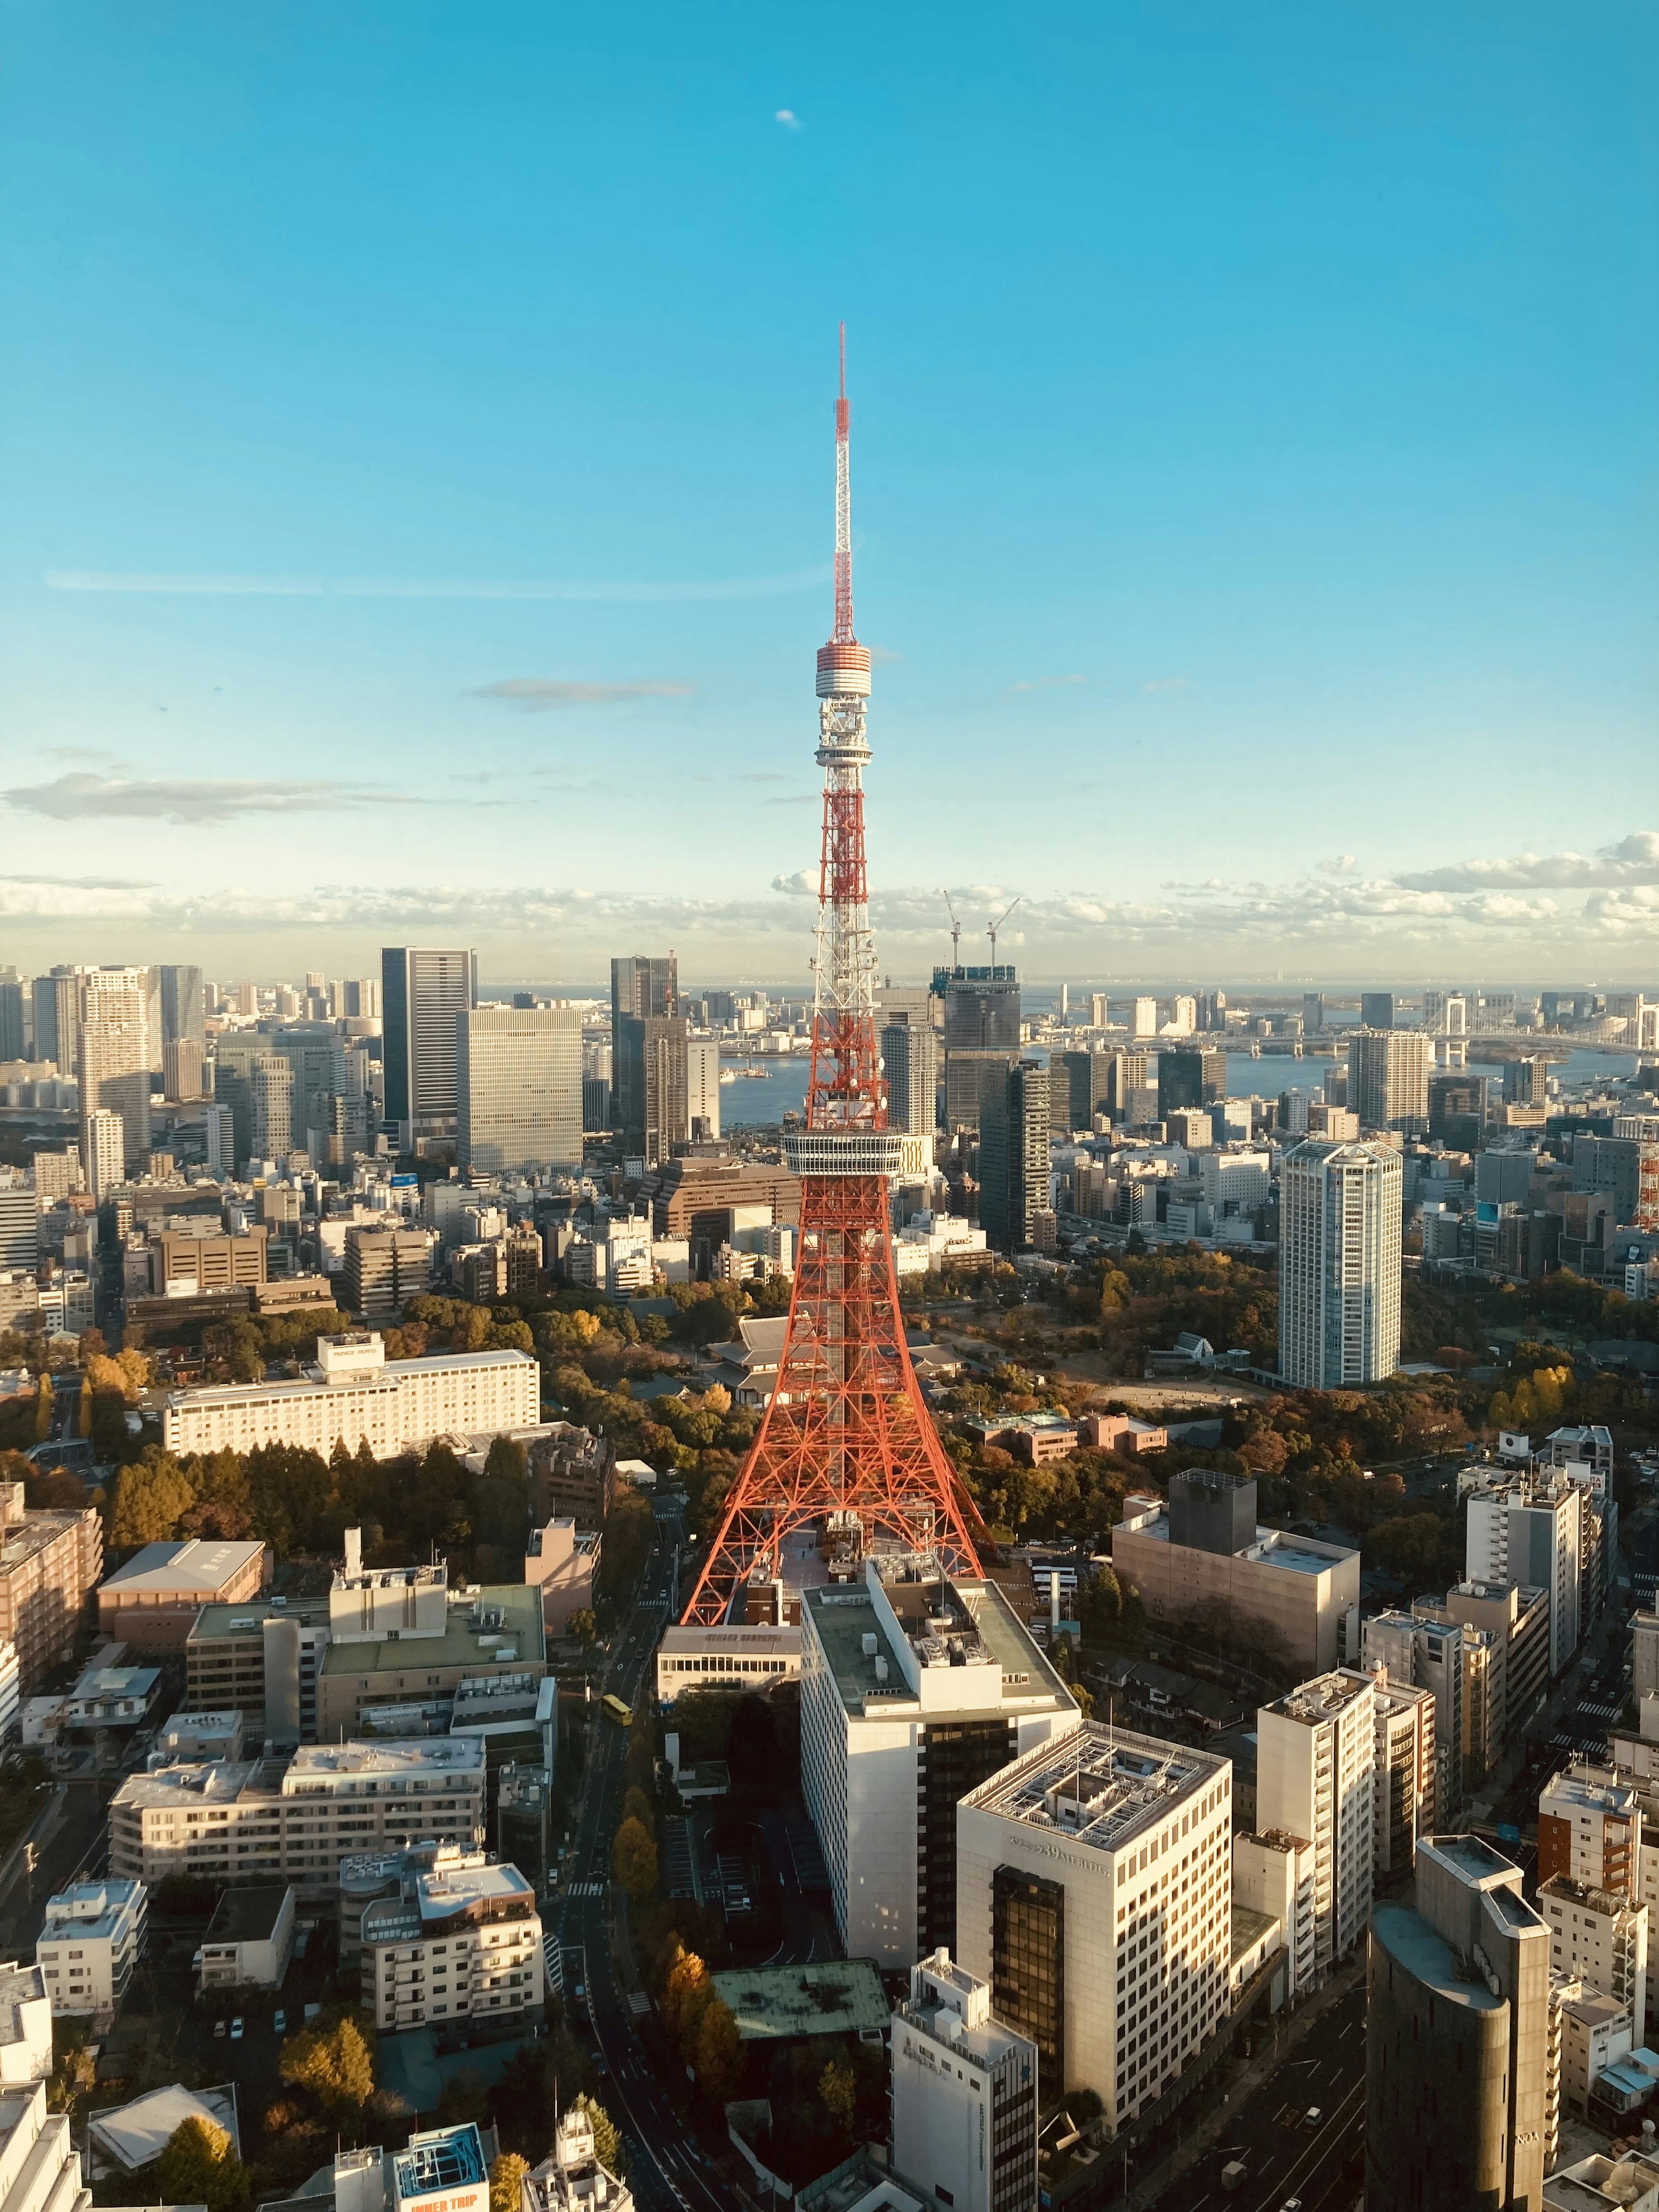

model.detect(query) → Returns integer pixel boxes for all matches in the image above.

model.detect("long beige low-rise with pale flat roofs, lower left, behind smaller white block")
[111,1736,486,1902]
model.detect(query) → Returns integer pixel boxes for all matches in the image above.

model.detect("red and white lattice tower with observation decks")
[686,325,984,1624]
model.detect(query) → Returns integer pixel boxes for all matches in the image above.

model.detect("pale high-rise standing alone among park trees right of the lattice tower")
[1278,1139,1402,1389]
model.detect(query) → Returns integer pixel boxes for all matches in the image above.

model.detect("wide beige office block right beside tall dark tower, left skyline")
[456,1007,582,1173]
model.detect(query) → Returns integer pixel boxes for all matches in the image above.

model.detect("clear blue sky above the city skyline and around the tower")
[0,0,1659,982]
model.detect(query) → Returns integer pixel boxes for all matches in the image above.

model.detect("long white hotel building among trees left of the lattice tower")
[162,1329,542,1460]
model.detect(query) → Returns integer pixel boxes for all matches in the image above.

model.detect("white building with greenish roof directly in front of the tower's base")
[801,1560,1080,1971]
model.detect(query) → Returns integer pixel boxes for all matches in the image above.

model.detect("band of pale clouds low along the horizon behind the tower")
[0,827,1659,978]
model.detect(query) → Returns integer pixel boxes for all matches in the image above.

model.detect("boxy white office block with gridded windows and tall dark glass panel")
[956,1721,1232,2128]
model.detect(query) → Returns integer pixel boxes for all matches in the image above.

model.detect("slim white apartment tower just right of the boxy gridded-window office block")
[1256,1670,1376,1969]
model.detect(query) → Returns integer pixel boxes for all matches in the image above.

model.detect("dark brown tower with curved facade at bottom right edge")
[1365,1836,1551,2212]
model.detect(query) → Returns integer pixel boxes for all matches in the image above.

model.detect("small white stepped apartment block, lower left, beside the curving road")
[361,1865,542,2033]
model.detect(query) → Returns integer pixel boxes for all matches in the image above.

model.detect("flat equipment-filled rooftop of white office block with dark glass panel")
[962,1721,1230,1851]
